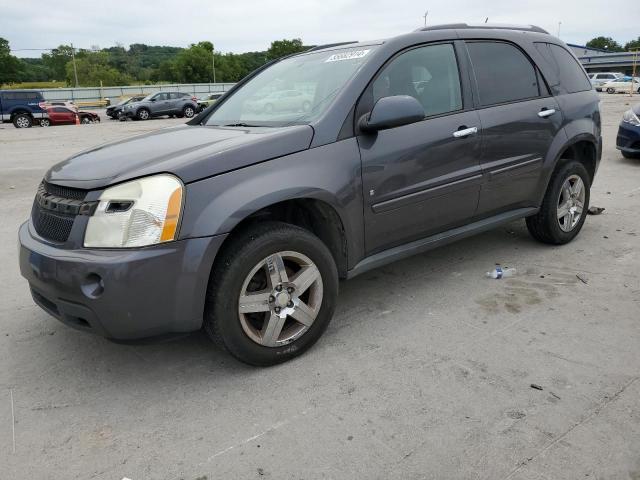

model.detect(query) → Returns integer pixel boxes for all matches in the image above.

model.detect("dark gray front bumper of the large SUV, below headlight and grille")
[19,222,226,341]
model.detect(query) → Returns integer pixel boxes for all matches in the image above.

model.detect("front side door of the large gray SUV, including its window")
[356,42,482,254]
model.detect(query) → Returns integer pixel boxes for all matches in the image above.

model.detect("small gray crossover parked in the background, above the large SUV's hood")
[122,92,198,120]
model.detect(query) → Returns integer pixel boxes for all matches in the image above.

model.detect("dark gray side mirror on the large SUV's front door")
[358,95,424,133]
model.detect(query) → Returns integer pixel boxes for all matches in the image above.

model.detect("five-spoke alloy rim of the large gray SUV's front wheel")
[238,251,323,347]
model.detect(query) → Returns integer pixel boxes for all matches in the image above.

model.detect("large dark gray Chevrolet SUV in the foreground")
[19,24,602,365]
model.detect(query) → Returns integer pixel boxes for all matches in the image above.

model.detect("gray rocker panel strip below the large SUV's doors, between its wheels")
[347,207,538,278]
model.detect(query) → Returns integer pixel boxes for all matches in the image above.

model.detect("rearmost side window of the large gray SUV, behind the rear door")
[536,43,592,93]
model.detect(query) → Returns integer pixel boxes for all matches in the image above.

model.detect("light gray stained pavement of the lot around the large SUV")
[0,94,640,480]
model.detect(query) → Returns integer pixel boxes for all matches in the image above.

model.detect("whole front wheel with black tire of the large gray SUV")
[204,222,338,366]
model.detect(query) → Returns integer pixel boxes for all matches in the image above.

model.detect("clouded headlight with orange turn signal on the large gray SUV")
[84,174,183,248]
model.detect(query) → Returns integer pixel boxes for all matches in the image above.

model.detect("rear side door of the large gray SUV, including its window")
[465,40,562,217]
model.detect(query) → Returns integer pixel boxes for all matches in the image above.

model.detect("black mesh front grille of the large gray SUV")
[31,181,87,243]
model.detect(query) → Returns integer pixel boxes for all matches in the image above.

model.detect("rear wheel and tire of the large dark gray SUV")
[526,160,591,245]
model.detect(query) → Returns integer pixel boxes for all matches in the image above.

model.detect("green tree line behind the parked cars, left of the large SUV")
[0,38,310,87]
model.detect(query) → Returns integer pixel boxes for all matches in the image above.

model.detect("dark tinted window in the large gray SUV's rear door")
[467,42,540,106]
